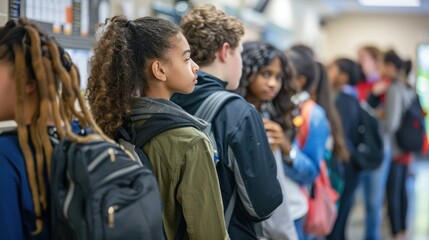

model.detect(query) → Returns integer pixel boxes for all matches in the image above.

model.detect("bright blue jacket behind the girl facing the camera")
[284,100,330,185]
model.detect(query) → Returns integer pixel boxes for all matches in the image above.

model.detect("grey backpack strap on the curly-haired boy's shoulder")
[194,91,241,122]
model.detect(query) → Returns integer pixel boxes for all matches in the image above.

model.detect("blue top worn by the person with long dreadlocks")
[0,131,50,240]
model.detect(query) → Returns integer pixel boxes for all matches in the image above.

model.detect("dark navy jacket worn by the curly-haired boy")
[172,71,283,239]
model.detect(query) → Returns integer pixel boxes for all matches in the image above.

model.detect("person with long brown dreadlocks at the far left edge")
[0,18,107,239]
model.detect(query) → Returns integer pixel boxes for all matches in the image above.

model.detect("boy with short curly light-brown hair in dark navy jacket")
[172,5,283,239]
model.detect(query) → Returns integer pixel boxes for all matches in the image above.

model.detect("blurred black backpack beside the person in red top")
[351,102,384,170]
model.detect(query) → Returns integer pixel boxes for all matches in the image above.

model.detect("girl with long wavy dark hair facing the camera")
[236,42,299,239]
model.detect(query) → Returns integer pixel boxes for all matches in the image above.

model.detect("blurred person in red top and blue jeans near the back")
[356,45,392,240]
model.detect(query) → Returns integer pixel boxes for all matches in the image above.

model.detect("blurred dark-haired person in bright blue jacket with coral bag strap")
[284,49,330,239]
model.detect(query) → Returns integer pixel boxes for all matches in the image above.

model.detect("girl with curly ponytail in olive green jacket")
[88,16,228,239]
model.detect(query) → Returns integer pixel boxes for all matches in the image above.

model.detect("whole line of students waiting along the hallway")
[0,5,422,240]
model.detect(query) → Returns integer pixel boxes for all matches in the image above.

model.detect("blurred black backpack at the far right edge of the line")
[395,96,426,152]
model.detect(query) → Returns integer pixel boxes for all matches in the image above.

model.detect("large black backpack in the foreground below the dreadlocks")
[51,126,163,240]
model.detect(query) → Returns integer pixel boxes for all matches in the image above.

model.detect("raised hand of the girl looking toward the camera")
[262,118,291,155]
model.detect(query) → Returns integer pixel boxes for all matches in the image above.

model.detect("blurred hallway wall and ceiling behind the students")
[0,0,429,239]
